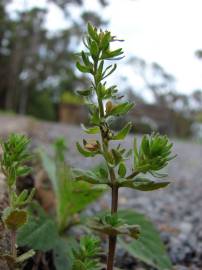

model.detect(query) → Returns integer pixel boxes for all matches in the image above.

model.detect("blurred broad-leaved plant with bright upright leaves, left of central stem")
[18,138,105,270]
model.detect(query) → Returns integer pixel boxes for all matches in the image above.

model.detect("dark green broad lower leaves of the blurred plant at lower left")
[17,203,73,270]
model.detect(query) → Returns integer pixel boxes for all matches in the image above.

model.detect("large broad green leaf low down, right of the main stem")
[119,210,172,270]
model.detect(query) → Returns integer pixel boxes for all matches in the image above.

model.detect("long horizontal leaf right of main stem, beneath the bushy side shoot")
[119,177,170,191]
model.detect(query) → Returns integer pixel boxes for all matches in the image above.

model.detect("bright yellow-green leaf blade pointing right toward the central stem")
[40,146,103,232]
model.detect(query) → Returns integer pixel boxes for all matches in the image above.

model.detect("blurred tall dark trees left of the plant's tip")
[0,0,106,118]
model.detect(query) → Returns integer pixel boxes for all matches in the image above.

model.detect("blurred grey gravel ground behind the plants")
[0,117,202,270]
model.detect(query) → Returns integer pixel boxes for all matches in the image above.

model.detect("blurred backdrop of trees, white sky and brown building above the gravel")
[0,0,202,140]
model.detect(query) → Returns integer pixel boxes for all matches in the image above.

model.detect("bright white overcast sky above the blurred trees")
[9,0,202,94]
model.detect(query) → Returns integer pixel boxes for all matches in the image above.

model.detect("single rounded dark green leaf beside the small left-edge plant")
[17,205,58,252]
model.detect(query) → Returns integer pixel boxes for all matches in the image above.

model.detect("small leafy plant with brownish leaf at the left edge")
[0,134,34,269]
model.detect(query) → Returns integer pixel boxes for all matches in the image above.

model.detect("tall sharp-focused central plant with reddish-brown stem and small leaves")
[75,23,173,270]
